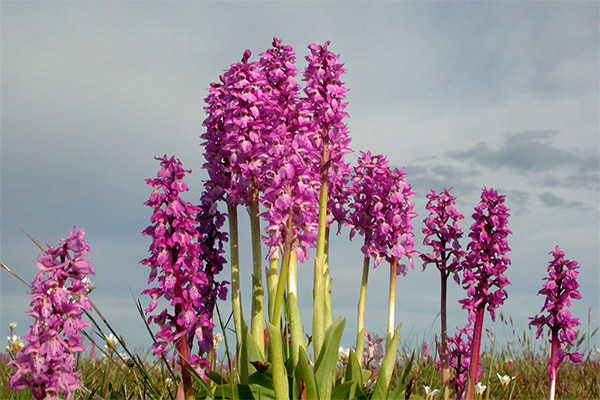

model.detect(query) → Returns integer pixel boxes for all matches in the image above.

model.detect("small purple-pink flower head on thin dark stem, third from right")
[421,189,465,283]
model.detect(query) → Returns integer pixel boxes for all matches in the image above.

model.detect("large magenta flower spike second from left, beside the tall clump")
[141,155,226,377]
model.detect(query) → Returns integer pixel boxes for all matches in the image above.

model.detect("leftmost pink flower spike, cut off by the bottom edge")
[8,228,94,399]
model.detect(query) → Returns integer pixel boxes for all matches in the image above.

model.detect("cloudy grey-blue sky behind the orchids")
[0,1,600,354]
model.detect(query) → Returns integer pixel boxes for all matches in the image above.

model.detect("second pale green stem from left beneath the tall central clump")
[250,194,265,355]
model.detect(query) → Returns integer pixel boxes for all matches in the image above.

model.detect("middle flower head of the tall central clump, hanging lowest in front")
[260,38,320,262]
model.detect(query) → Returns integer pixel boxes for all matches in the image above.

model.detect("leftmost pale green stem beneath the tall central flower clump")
[227,204,244,352]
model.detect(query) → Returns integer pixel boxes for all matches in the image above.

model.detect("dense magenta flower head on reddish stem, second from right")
[459,188,512,320]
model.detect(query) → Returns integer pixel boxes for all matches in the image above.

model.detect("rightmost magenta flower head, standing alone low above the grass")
[529,246,583,368]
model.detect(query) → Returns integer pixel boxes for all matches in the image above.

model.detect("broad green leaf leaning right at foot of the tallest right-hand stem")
[315,318,346,400]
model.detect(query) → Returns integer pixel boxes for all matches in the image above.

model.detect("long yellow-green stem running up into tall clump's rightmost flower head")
[312,143,329,360]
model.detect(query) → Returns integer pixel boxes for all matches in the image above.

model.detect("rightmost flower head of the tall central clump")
[303,41,352,231]
